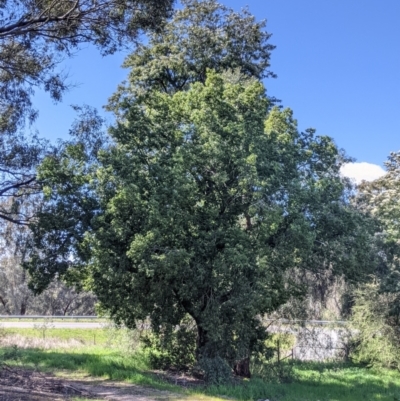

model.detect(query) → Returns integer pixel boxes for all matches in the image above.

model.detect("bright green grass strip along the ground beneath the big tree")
[0,329,400,401]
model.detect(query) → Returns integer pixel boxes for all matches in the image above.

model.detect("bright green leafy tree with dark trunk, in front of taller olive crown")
[30,72,372,375]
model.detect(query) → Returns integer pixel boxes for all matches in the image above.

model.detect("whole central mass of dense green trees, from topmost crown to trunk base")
[26,0,382,376]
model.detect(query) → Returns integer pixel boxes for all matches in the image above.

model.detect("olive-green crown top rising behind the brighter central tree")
[108,0,275,112]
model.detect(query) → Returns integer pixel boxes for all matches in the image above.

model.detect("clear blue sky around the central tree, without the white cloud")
[32,0,400,174]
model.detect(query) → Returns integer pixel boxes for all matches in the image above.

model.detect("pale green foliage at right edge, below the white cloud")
[352,153,400,368]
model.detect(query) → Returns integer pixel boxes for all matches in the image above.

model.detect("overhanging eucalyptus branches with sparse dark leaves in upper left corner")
[0,0,173,224]
